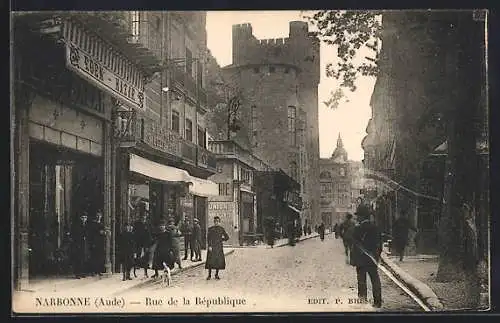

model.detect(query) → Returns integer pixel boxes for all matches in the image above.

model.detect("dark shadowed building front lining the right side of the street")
[362,11,489,268]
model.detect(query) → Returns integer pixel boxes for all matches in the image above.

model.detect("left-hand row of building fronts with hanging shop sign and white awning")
[11,12,217,289]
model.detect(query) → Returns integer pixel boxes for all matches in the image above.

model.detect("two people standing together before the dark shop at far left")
[69,210,107,279]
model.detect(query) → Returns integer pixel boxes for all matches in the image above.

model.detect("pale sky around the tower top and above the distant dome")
[206,11,375,161]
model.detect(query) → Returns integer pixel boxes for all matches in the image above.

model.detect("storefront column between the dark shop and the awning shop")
[103,117,115,274]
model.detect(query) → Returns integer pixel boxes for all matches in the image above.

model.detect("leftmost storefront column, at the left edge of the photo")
[13,86,34,290]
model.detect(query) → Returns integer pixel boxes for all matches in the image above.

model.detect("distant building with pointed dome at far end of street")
[320,134,355,227]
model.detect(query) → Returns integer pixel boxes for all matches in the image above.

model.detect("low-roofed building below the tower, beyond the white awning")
[208,140,271,245]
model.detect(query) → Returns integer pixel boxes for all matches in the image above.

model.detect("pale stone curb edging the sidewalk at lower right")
[380,254,444,311]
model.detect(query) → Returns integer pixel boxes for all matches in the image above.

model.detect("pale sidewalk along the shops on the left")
[21,248,234,296]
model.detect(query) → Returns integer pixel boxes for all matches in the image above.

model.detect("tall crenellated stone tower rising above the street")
[224,21,320,225]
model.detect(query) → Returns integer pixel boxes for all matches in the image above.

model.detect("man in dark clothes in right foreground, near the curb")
[351,206,382,308]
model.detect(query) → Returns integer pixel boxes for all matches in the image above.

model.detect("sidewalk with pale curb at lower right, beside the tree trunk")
[382,253,486,311]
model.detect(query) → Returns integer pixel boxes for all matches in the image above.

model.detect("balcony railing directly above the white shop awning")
[117,111,181,157]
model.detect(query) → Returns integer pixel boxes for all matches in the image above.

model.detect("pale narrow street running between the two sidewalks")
[127,235,421,312]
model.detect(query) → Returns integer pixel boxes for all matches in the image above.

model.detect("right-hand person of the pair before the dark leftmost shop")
[89,210,106,276]
